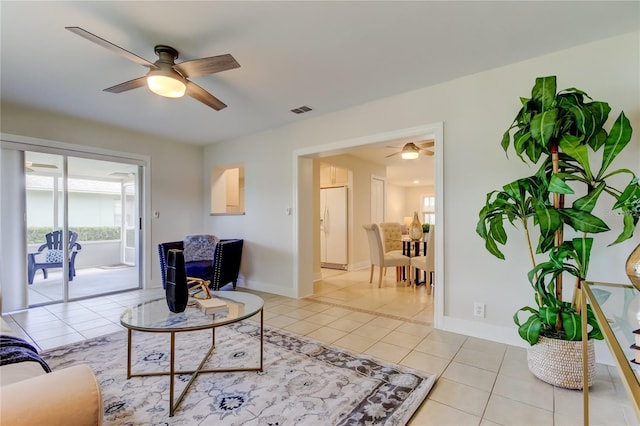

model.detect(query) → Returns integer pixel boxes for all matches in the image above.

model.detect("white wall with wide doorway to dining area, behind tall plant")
[205,32,640,343]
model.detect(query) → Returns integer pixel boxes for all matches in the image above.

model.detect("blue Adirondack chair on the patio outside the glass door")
[27,231,82,284]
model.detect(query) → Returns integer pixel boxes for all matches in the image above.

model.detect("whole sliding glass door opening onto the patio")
[25,151,141,306]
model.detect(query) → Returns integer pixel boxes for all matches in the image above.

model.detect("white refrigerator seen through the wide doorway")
[320,186,348,271]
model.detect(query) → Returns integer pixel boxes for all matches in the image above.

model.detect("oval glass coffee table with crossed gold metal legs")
[120,291,264,417]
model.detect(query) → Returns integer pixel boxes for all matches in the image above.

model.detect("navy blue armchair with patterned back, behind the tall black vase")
[158,237,244,291]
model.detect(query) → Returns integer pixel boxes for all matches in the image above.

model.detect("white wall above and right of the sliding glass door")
[0,102,203,287]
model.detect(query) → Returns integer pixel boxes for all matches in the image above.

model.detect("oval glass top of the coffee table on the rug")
[120,291,264,332]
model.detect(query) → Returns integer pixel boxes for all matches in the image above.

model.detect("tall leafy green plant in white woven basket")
[476,76,640,388]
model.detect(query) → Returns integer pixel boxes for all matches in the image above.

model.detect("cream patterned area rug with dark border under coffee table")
[42,321,435,426]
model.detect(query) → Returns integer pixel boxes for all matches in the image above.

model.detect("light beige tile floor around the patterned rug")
[4,270,638,426]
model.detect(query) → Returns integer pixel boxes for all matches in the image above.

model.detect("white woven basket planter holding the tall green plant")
[527,337,596,389]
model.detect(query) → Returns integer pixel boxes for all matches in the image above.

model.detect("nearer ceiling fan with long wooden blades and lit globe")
[65,27,240,111]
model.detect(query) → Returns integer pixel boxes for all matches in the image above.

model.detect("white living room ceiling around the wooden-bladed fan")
[0,1,640,185]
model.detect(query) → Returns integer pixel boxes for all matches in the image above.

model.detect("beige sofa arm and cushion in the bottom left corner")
[0,308,102,426]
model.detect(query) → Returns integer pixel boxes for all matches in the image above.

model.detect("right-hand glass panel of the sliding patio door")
[68,157,140,299]
